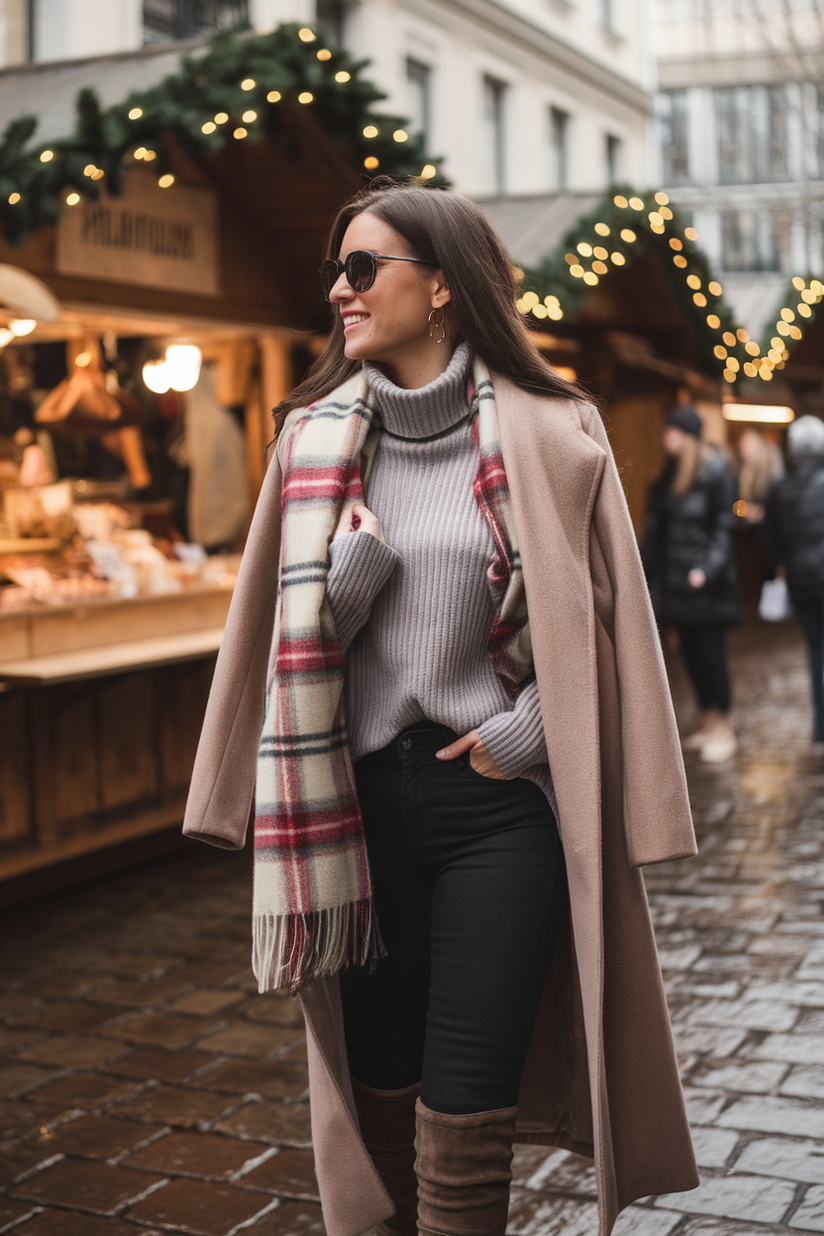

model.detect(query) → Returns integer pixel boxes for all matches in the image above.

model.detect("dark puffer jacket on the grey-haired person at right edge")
[763,455,824,604]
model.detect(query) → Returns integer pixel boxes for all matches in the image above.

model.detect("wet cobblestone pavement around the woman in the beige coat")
[0,627,824,1236]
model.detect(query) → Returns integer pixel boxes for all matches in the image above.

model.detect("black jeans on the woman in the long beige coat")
[341,726,567,1115]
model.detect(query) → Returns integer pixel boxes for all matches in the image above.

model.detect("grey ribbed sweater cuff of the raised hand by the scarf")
[326,530,400,651]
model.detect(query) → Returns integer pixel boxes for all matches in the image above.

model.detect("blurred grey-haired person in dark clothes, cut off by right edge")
[765,417,824,743]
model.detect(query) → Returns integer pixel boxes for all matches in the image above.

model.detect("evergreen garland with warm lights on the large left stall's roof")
[0,22,444,245]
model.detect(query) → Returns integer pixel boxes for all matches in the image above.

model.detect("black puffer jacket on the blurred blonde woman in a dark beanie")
[641,451,739,627]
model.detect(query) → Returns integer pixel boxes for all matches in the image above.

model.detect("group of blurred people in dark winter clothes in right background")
[641,404,824,764]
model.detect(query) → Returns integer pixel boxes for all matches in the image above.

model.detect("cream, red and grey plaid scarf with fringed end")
[252,358,532,993]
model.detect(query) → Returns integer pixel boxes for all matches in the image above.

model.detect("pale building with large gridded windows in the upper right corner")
[655,0,824,334]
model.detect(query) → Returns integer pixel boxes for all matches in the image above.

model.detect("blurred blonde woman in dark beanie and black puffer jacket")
[641,404,739,764]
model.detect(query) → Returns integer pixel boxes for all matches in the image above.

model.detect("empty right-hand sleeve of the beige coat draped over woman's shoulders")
[583,407,697,866]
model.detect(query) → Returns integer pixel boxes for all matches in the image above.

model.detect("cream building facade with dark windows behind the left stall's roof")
[0,0,655,197]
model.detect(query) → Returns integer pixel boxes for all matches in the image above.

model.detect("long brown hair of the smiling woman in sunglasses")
[274,177,586,434]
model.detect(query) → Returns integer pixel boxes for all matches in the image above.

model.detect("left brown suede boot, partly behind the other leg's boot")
[352,1078,420,1236]
